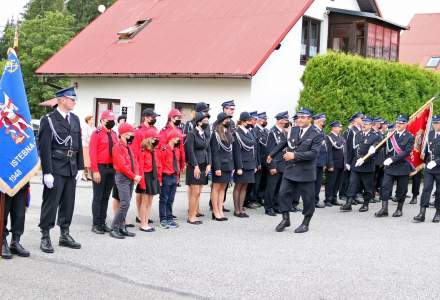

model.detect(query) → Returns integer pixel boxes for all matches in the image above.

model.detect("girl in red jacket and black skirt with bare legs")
[136,127,162,232]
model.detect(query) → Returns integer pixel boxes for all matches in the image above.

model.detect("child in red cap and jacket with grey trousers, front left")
[110,123,142,239]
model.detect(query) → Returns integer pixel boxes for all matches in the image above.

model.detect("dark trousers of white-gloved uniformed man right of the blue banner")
[39,174,76,230]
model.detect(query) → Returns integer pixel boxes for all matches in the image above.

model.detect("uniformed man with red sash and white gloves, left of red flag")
[375,115,414,217]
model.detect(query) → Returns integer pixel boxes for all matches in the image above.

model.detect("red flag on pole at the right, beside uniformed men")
[407,101,432,171]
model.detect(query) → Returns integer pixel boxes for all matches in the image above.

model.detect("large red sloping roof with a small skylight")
[37,0,313,77]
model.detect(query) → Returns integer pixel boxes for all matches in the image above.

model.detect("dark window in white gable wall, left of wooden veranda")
[300,17,321,65]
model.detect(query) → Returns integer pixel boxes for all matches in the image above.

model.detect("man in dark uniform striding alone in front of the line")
[268,108,323,233]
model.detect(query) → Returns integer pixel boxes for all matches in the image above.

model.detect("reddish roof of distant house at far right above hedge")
[399,13,440,70]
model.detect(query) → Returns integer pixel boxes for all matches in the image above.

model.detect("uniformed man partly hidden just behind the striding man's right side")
[313,114,328,208]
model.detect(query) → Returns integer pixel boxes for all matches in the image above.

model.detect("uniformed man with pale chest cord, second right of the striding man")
[324,121,345,207]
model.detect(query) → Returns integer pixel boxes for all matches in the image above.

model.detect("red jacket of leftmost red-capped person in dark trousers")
[89,127,118,172]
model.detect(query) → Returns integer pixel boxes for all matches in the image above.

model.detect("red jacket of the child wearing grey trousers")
[112,142,143,181]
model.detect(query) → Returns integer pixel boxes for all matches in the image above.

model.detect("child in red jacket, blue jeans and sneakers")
[159,129,185,229]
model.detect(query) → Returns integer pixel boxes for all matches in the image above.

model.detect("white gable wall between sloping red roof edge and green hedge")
[251,0,359,118]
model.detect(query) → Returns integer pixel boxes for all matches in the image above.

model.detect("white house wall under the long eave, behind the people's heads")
[73,78,252,128]
